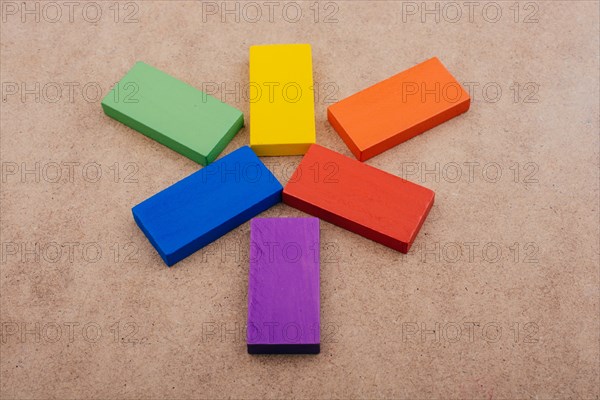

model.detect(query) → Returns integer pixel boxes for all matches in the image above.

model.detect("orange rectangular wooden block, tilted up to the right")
[327,58,471,161]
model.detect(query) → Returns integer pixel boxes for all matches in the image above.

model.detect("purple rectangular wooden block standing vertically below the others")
[247,218,321,354]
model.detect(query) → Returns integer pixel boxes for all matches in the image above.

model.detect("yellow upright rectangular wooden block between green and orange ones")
[249,44,316,156]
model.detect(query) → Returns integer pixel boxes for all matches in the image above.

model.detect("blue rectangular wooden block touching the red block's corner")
[132,146,283,266]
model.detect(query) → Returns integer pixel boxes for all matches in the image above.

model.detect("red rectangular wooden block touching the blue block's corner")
[283,144,434,253]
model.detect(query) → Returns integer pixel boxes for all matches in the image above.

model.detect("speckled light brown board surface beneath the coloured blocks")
[0,1,600,399]
